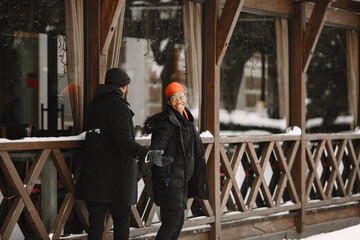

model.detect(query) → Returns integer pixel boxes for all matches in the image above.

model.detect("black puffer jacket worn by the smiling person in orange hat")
[145,106,209,209]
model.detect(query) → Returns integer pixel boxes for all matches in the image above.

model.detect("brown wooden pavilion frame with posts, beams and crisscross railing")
[0,0,360,240]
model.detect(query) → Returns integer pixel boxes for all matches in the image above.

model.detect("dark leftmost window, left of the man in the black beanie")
[0,0,73,138]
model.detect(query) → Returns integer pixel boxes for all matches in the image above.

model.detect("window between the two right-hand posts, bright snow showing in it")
[220,12,289,135]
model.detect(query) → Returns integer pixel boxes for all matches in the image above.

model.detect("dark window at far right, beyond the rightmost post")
[306,26,357,133]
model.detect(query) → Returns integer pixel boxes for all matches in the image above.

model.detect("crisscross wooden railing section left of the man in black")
[0,138,88,240]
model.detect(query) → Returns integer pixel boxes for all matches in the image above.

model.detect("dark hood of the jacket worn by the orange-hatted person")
[144,105,194,134]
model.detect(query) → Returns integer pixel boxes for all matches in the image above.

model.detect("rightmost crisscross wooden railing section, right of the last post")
[305,134,360,208]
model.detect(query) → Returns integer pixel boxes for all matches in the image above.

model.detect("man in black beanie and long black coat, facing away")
[77,68,169,240]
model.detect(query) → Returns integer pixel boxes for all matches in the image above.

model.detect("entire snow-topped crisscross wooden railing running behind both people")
[0,134,360,239]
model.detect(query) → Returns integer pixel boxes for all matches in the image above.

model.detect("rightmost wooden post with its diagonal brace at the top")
[292,0,331,232]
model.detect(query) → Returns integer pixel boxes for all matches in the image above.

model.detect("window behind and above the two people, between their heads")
[119,1,187,133]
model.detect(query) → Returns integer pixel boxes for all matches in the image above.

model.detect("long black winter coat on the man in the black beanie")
[76,84,149,205]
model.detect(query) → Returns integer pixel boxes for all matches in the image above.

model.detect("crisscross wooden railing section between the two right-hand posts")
[220,135,301,221]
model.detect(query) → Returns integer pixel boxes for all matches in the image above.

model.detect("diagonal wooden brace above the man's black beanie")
[100,0,126,55]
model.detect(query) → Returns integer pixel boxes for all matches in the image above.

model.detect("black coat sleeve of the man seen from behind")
[108,102,149,160]
